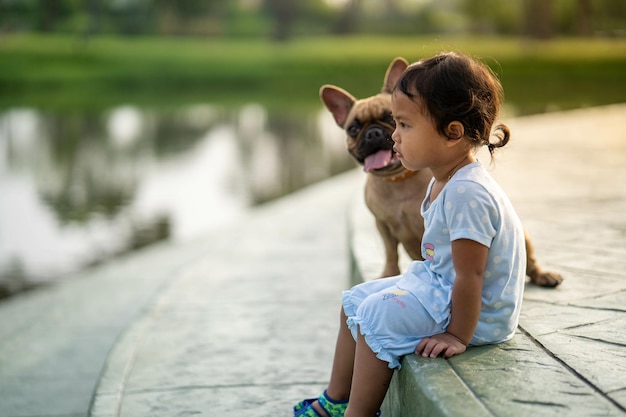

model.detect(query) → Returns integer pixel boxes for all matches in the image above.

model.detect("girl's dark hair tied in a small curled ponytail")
[396,52,511,155]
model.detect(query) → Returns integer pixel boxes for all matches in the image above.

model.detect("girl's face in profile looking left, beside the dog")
[391,90,449,171]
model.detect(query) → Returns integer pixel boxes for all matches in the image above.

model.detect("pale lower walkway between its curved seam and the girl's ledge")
[92,173,356,417]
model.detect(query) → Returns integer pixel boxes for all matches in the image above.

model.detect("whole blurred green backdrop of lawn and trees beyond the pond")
[0,0,626,113]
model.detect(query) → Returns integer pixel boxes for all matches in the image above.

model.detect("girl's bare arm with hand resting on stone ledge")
[415,239,489,358]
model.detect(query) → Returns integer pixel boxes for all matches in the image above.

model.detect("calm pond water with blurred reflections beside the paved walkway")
[0,104,354,296]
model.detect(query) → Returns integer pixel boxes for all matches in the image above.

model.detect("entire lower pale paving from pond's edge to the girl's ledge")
[0,167,361,417]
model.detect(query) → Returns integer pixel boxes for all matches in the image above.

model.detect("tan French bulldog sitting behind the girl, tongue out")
[320,58,563,287]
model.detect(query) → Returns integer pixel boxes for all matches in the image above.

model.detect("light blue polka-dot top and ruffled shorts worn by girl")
[343,161,526,368]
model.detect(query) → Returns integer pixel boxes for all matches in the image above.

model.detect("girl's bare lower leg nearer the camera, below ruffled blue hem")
[345,332,393,417]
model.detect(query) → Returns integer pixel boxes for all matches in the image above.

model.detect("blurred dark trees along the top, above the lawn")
[0,0,626,40]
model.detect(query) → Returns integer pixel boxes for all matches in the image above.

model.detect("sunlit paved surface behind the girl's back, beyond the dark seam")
[497,105,626,415]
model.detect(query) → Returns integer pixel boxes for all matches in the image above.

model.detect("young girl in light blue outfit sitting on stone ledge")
[294,53,526,417]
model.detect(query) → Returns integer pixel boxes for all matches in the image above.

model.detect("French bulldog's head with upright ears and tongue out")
[320,58,408,176]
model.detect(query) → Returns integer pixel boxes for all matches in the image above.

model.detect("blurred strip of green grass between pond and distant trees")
[0,35,626,113]
